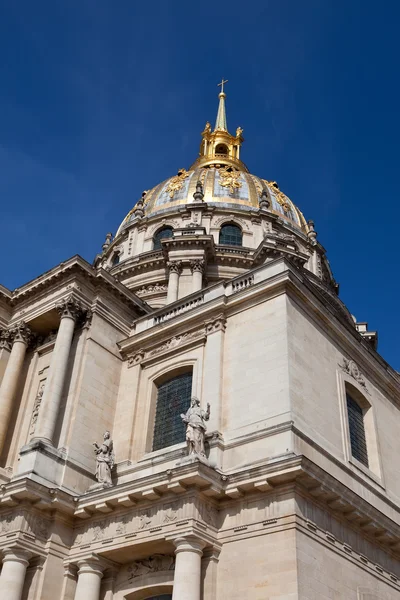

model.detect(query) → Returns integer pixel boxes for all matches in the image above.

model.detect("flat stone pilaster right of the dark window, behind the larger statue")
[203,314,226,432]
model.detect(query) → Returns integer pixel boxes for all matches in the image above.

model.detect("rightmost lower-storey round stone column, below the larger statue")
[172,536,205,600]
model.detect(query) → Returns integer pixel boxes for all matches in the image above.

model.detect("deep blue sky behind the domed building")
[0,0,400,369]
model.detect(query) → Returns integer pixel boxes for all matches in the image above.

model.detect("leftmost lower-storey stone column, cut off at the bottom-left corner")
[0,548,31,600]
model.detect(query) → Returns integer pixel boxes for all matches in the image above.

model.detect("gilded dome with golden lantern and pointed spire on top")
[117,80,307,235]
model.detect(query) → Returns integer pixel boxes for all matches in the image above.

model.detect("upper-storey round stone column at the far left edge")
[0,321,32,453]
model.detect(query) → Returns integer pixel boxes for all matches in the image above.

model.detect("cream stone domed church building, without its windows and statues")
[0,90,400,600]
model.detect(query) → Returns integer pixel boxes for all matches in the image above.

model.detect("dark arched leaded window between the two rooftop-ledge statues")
[153,371,192,450]
